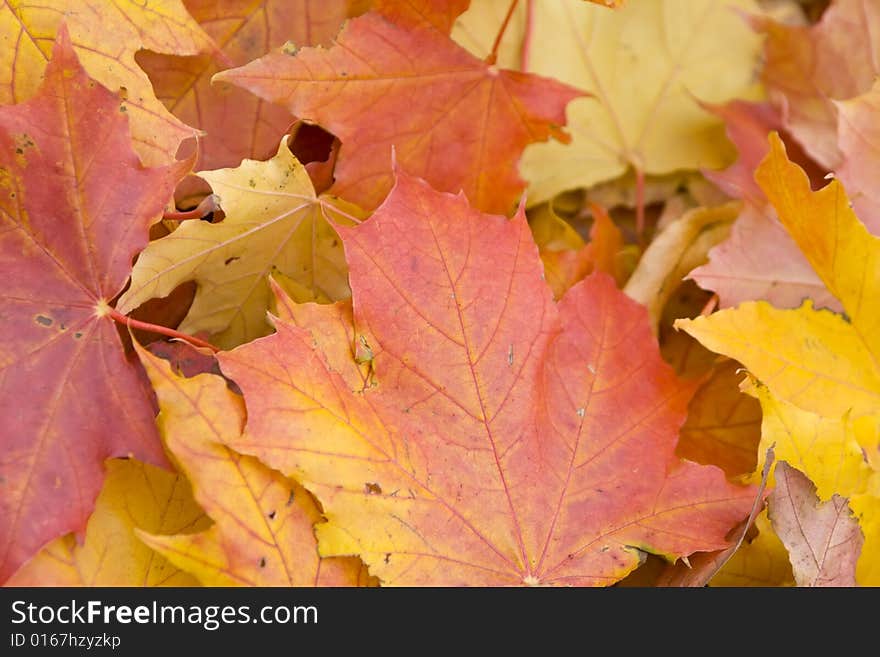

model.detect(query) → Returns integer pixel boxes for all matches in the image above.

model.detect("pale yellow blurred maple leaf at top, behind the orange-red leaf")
[459,0,760,203]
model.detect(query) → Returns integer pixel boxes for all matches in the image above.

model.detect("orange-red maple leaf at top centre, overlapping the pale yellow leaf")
[214,0,582,212]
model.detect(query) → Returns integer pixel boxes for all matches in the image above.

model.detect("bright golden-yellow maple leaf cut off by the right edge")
[679,133,880,416]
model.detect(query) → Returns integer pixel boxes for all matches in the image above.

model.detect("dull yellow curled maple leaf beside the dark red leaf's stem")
[119,137,363,347]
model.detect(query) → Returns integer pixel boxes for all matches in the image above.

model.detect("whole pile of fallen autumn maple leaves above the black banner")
[0,0,880,586]
